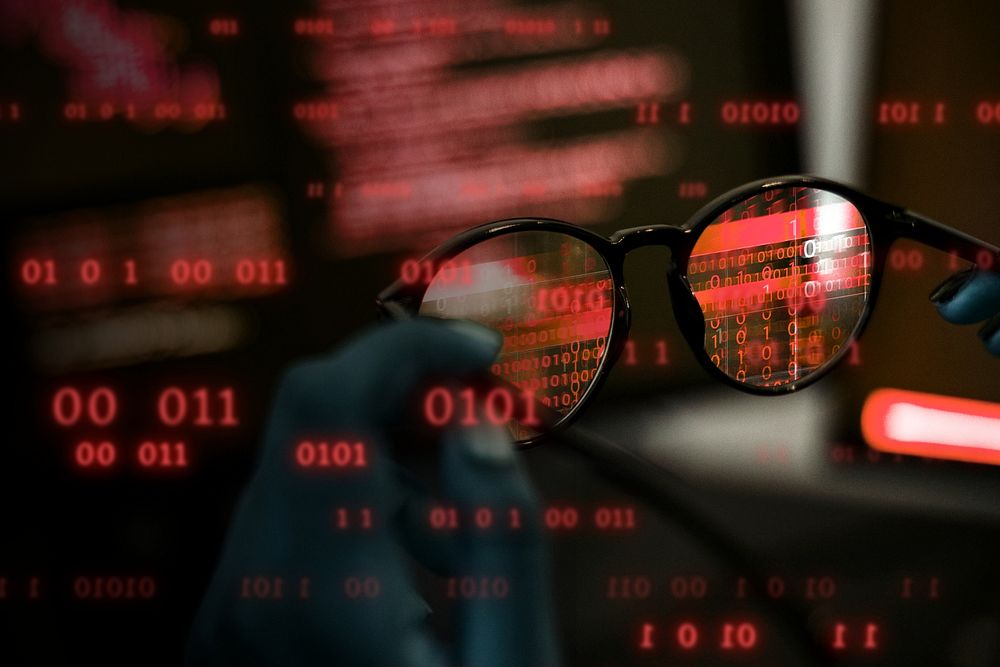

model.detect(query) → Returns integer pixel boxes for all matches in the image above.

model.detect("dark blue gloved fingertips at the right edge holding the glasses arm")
[930,267,1000,356]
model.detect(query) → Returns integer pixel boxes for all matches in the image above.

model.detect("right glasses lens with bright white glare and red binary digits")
[687,188,872,387]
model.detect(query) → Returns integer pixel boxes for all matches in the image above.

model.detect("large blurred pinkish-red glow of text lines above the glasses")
[296,0,687,255]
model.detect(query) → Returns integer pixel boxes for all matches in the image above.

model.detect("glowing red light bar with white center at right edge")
[861,389,1000,465]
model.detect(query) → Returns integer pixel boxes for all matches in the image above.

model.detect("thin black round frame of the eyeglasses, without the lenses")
[376,175,1000,447]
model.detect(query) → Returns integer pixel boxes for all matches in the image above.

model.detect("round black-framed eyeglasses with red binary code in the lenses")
[377,176,1000,446]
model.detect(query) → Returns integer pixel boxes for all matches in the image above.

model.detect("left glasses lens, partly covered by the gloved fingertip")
[420,231,614,440]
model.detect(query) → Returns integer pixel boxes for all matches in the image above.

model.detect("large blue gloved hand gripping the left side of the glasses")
[187,318,558,667]
